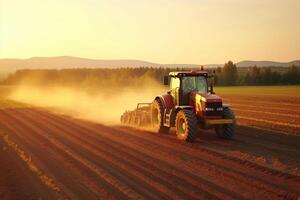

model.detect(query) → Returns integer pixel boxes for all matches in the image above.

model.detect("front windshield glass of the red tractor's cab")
[181,76,207,94]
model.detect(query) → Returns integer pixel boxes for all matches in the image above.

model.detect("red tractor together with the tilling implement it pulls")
[121,70,236,141]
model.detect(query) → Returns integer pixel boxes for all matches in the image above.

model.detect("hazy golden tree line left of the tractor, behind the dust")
[2,68,174,90]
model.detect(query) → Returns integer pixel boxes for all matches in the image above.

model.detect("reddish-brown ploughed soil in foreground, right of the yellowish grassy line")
[0,108,300,199]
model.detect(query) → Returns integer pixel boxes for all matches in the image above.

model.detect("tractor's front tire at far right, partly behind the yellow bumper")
[215,107,236,140]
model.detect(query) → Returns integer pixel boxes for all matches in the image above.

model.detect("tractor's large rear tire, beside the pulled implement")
[151,99,170,133]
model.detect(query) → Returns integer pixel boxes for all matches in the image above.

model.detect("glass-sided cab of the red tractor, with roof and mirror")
[164,71,212,106]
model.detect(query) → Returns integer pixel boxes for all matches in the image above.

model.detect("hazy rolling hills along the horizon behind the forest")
[0,56,300,73]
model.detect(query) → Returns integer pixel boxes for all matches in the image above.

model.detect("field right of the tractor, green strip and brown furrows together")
[217,86,300,135]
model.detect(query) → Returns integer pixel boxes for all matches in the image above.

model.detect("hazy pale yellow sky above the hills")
[0,0,300,64]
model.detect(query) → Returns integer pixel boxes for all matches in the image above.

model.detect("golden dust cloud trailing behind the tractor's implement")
[9,81,166,125]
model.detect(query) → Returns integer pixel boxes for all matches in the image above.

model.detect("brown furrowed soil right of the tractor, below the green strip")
[224,95,300,135]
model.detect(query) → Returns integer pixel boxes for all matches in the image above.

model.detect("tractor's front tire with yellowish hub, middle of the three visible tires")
[175,109,198,142]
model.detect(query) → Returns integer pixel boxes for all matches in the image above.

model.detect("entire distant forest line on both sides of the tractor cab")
[2,61,300,87]
